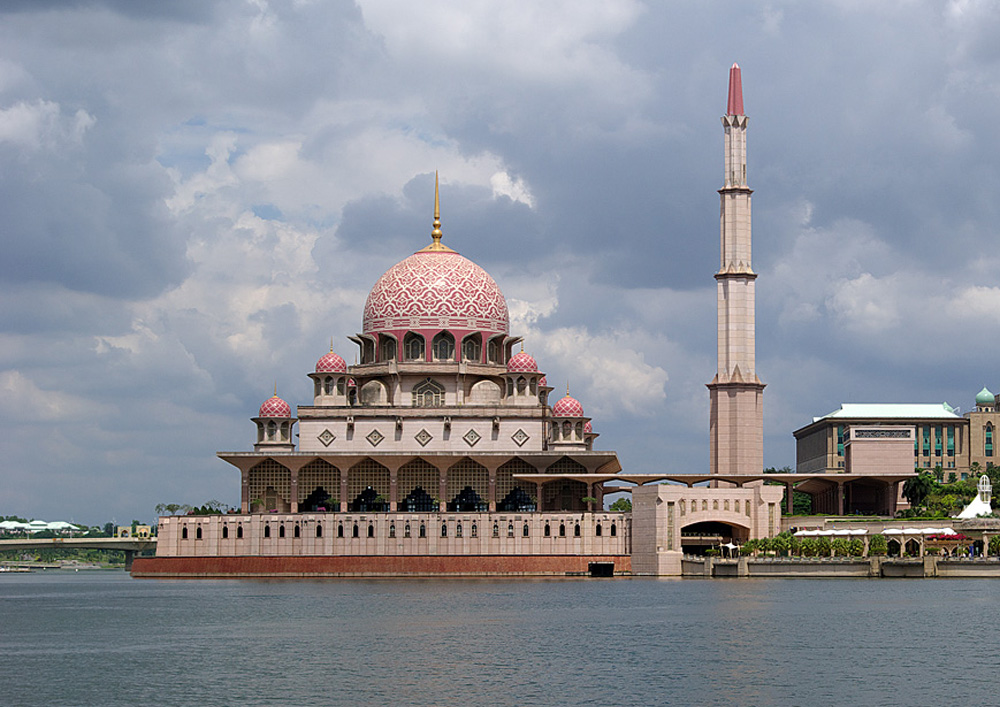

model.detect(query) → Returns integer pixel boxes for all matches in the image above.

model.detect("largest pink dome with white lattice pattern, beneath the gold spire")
[362,251,509,334]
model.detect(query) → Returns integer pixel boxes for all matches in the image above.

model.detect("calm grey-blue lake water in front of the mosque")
[0,572,1000,706]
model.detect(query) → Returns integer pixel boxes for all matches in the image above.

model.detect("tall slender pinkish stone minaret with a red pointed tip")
[708,64,764,475]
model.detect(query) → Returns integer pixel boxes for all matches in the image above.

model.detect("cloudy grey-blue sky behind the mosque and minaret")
[0,0,1000,524]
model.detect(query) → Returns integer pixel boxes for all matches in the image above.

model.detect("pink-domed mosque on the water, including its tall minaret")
[132,64,852,577]
